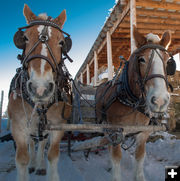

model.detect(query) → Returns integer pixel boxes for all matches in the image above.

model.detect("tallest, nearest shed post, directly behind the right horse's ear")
[130,0,136,53]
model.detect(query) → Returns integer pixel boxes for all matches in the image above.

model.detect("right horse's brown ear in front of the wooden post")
[133,25,147,48]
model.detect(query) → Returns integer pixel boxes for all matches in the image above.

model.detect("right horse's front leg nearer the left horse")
[109,145,122,181]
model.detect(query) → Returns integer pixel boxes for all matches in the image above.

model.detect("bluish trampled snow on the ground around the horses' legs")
[0,129,180,181]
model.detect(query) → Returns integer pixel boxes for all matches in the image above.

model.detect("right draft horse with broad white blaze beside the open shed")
[96,27,171,181]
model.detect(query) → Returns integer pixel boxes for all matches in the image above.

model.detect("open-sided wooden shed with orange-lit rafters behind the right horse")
[75,0,180,130]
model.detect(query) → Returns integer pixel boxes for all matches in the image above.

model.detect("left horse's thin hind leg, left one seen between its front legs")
[29,139,36,173]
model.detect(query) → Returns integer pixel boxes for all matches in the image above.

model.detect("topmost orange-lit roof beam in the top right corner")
[136,0,180,11]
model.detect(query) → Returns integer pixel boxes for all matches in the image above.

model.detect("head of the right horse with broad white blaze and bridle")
[130,27,174,115]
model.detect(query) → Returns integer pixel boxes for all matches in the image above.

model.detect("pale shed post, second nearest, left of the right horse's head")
[106,31,113,80]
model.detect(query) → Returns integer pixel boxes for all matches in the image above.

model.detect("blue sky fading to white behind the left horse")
[0,0,115,113]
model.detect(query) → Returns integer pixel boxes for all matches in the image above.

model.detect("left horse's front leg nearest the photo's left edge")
[12,121,29,181]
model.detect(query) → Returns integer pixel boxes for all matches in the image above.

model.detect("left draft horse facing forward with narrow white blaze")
[8,5,71,181]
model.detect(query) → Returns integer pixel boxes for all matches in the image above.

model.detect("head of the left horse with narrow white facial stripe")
[14,5,70,102]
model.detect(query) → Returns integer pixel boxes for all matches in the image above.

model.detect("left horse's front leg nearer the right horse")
[47,131,64,181]
